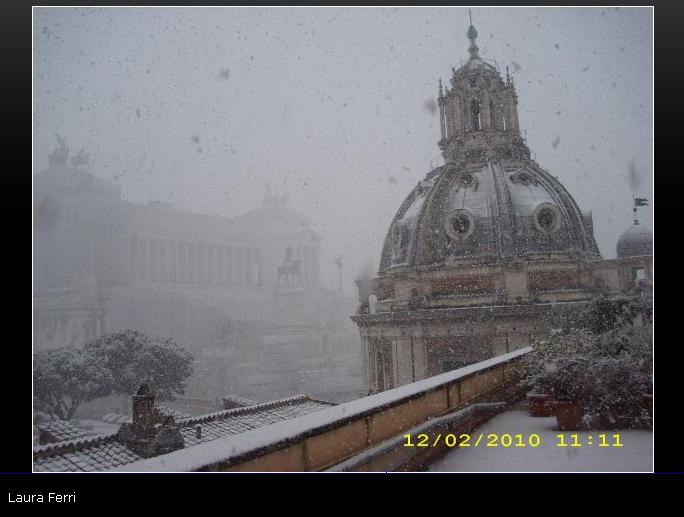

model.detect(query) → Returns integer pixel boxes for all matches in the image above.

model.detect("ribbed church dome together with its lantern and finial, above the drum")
[380,20,601,273]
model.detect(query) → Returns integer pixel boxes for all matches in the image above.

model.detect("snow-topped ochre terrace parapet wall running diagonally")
[111,347,532,472]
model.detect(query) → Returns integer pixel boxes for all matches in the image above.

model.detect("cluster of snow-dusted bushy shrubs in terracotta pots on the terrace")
[525,299,653,430]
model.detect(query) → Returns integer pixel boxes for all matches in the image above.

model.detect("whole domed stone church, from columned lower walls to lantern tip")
[352,19,652,393]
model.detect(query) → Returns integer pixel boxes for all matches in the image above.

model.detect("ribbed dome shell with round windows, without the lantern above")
[380,159,600,272]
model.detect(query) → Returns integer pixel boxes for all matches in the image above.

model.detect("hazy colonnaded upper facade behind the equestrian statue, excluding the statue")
[33,144,322,348]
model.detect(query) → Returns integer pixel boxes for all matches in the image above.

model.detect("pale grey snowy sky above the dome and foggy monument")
[33,7,653,291]
